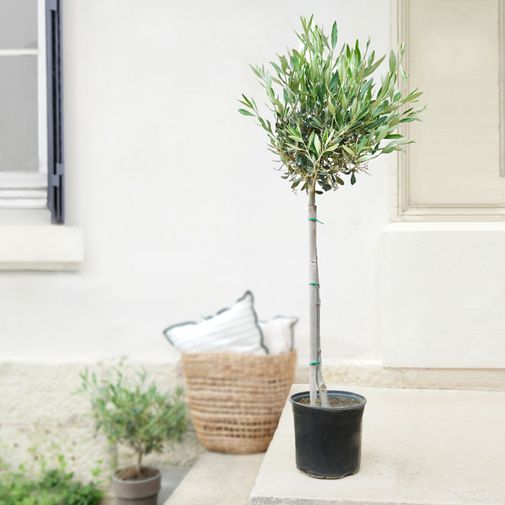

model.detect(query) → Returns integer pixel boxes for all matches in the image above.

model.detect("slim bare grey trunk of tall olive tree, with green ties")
[309,185,329,407]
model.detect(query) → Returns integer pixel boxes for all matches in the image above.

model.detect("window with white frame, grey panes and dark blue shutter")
[0,0,64,223]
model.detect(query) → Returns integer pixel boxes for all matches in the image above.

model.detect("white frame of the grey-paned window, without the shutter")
[0,0,48,209]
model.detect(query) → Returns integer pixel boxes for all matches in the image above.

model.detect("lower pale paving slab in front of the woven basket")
[165,452,264,505]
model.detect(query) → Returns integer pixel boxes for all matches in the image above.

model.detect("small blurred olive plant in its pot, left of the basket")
[81,365,187,505]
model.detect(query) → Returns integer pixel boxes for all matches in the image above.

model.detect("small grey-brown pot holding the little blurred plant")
[112,467,161,505]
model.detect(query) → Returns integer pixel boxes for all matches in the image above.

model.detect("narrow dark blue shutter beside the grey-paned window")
[46,0,65,224]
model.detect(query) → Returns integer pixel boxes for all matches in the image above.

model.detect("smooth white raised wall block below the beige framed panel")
[380,222,505,369]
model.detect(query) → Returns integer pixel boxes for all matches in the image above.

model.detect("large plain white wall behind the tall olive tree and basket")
[0,0,393,361]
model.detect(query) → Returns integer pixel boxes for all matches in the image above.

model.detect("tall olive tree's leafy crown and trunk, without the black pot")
[239,16,423,406]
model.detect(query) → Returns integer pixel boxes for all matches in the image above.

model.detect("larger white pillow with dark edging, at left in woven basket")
[163,291,268,354]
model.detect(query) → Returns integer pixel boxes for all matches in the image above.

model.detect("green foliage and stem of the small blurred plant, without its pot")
[80,364,187,478]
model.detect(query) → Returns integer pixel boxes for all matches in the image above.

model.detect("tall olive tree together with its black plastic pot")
[239,17,421,478]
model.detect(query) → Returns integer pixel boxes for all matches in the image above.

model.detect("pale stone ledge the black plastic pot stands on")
[250,385,505,505]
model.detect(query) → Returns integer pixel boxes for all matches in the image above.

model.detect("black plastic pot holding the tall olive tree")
[291,391,366,479]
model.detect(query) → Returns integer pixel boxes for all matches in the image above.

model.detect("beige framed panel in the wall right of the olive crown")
[397,0,505,220]
